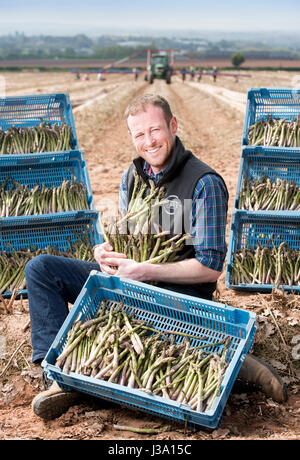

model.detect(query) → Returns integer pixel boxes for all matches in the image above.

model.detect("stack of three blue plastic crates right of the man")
[225,88,300,293]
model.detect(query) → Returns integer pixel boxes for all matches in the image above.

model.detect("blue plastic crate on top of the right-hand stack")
[242,88,300,150]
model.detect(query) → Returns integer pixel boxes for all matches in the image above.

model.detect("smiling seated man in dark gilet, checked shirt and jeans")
[25,94,286,419]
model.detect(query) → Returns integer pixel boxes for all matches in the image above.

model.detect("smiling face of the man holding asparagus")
[127,105,177,174]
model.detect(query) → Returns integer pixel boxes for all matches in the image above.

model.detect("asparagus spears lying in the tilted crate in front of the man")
[56,300,230,412]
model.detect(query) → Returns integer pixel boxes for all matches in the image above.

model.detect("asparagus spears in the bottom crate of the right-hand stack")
[231,235,300,286]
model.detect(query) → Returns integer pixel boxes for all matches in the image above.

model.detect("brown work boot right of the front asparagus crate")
[237,354,288,403]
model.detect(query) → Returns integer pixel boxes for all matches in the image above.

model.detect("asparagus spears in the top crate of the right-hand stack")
[248,115,300,147]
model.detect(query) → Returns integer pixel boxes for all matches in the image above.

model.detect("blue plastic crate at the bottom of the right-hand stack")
[225,211,300,294]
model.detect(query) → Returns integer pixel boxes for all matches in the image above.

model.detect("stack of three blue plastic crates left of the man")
[0,93,102,297]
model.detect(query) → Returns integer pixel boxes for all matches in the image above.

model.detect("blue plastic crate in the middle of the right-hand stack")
[235,146,300,212]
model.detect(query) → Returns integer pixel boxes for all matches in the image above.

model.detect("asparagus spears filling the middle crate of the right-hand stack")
[238,174,300,211]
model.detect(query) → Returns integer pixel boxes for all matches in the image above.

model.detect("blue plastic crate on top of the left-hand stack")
[0,93,79,150]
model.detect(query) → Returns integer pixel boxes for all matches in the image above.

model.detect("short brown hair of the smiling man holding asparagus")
[124,93,173,125]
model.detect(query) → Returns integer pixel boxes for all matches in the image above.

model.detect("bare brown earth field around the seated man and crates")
[0,71,300,440]
